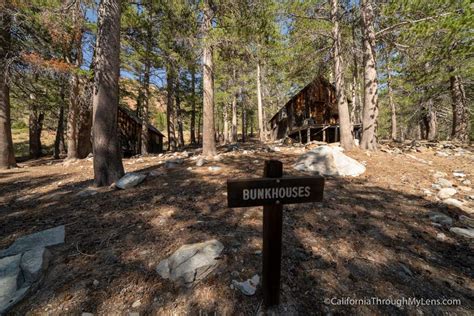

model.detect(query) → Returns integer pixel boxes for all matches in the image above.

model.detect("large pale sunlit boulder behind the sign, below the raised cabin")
[293,146,365,177]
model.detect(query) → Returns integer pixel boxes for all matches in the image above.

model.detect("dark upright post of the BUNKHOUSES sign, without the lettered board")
[262,160,283,307]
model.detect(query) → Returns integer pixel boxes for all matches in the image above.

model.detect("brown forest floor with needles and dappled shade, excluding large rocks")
[0,143,474,315]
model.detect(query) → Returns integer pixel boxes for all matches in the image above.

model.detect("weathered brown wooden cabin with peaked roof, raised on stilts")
[268,77,361,143]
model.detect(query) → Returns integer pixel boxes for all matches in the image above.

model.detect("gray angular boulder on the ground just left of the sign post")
[156,239,224,287]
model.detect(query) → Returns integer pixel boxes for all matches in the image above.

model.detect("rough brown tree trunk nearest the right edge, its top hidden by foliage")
[450,75,471,142]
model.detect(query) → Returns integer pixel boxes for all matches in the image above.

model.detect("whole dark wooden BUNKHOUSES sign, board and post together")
[227,160,324,307]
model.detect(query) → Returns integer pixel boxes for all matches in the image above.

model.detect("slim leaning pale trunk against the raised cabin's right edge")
[332,0,354,150]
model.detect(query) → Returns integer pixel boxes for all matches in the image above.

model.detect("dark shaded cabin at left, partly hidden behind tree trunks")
[118,106,165,157]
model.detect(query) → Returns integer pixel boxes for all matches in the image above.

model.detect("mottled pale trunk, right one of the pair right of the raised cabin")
[360,0,379,150]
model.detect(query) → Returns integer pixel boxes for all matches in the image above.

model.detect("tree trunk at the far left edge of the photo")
[0,10,16,169]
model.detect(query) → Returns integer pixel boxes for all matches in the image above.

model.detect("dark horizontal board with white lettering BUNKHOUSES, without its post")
[227,176,324,207]
